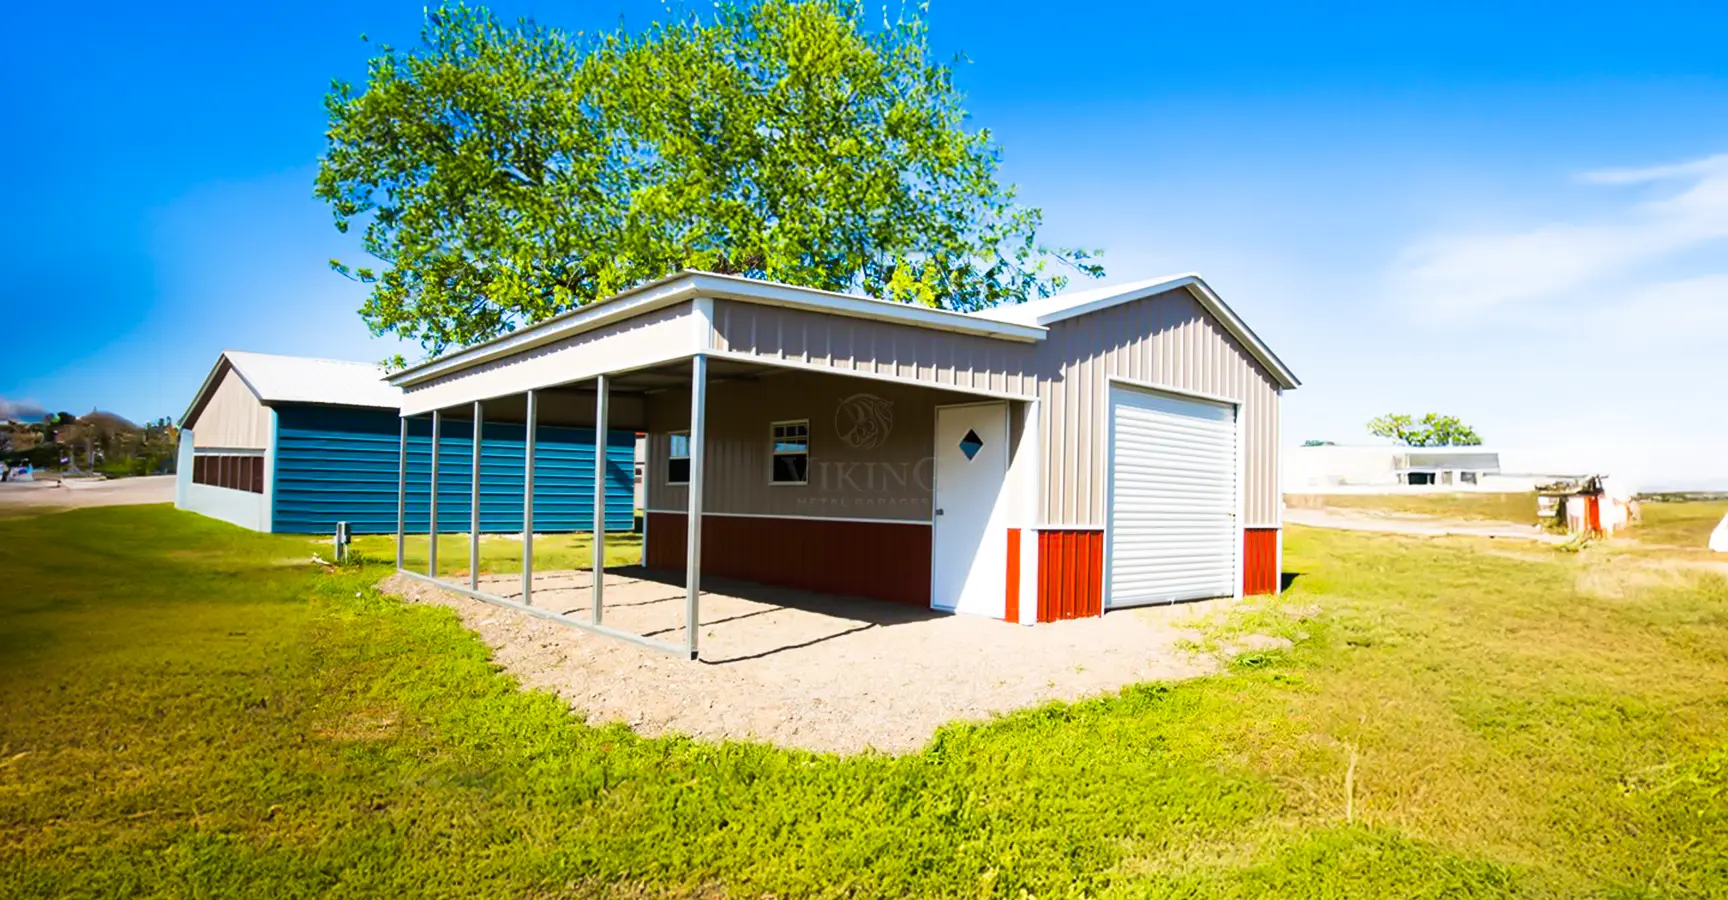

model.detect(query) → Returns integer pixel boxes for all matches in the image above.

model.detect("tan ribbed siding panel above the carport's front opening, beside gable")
[714,301,1037,397]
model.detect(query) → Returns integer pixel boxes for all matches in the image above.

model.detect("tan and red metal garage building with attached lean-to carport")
[381,273,1299,655]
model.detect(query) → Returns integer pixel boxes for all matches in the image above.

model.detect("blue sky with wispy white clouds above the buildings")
[0,0,1728,487]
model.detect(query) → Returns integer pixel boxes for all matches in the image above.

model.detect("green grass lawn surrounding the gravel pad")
[0,508,1728,898]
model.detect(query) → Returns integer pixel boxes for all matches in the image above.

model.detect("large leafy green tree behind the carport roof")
[316,0,1102,351]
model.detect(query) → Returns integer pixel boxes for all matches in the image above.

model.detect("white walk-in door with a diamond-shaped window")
[930,402,1007,618]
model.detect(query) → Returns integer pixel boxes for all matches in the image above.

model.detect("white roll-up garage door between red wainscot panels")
[1104,385,1239,606]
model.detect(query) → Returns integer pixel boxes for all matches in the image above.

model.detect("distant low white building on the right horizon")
[1284,444,1550,494]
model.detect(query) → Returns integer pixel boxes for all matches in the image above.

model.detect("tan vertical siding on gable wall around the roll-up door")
[1039,288,1280,527]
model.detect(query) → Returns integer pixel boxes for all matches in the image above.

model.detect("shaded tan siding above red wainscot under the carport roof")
[646,371,978,522]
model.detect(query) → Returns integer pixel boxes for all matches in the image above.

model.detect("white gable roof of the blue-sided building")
[180,351,403,423]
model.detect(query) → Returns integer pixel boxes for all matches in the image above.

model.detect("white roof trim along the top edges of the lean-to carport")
[391,271,1045,387]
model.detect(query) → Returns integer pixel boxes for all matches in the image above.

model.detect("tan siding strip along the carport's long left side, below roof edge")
[403,302,707,415]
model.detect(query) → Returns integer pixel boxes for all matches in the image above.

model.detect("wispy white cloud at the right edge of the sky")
[1391,154,1728,320]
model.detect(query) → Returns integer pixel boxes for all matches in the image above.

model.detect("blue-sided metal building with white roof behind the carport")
[175,351,636,534]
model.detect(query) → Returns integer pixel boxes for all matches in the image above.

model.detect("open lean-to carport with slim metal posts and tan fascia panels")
[392,273,1042,658]
